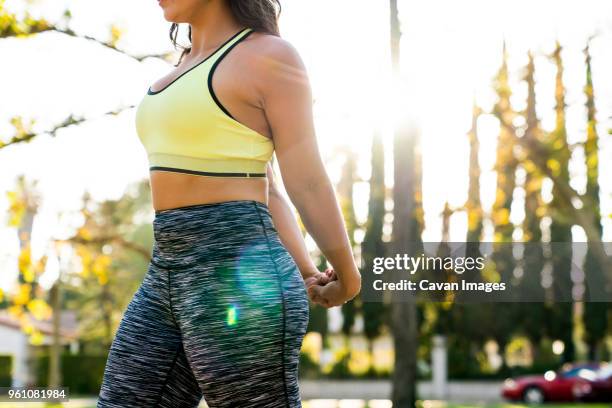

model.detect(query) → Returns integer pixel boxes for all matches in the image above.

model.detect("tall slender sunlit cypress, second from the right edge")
[547,41,575,362]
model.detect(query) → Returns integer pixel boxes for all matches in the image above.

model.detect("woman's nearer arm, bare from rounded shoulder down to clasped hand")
[254,38,361,306]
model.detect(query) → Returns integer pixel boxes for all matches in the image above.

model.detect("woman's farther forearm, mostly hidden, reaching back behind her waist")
[266,164,319,281]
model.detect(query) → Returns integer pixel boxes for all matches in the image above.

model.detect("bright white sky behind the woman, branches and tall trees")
[0,0,612,286]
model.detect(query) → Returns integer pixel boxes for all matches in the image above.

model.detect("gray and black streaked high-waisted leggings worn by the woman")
[97,200,309,408]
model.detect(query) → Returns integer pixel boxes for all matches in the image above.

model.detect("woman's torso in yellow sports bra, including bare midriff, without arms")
[137,29,273,210]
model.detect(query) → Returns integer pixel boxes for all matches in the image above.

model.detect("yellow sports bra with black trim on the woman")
[136,28,274,177]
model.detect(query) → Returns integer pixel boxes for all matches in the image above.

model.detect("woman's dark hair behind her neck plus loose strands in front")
[170,0,281,66]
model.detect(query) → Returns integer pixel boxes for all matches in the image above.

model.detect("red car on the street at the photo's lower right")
[502,363,601,404]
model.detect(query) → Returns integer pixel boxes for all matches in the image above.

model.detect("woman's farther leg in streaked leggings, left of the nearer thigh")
[97,264,202,408]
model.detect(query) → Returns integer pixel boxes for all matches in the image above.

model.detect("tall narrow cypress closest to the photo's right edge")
[583,39,610,361]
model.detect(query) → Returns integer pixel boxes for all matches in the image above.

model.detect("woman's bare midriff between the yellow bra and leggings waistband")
[150,171,268,211]
